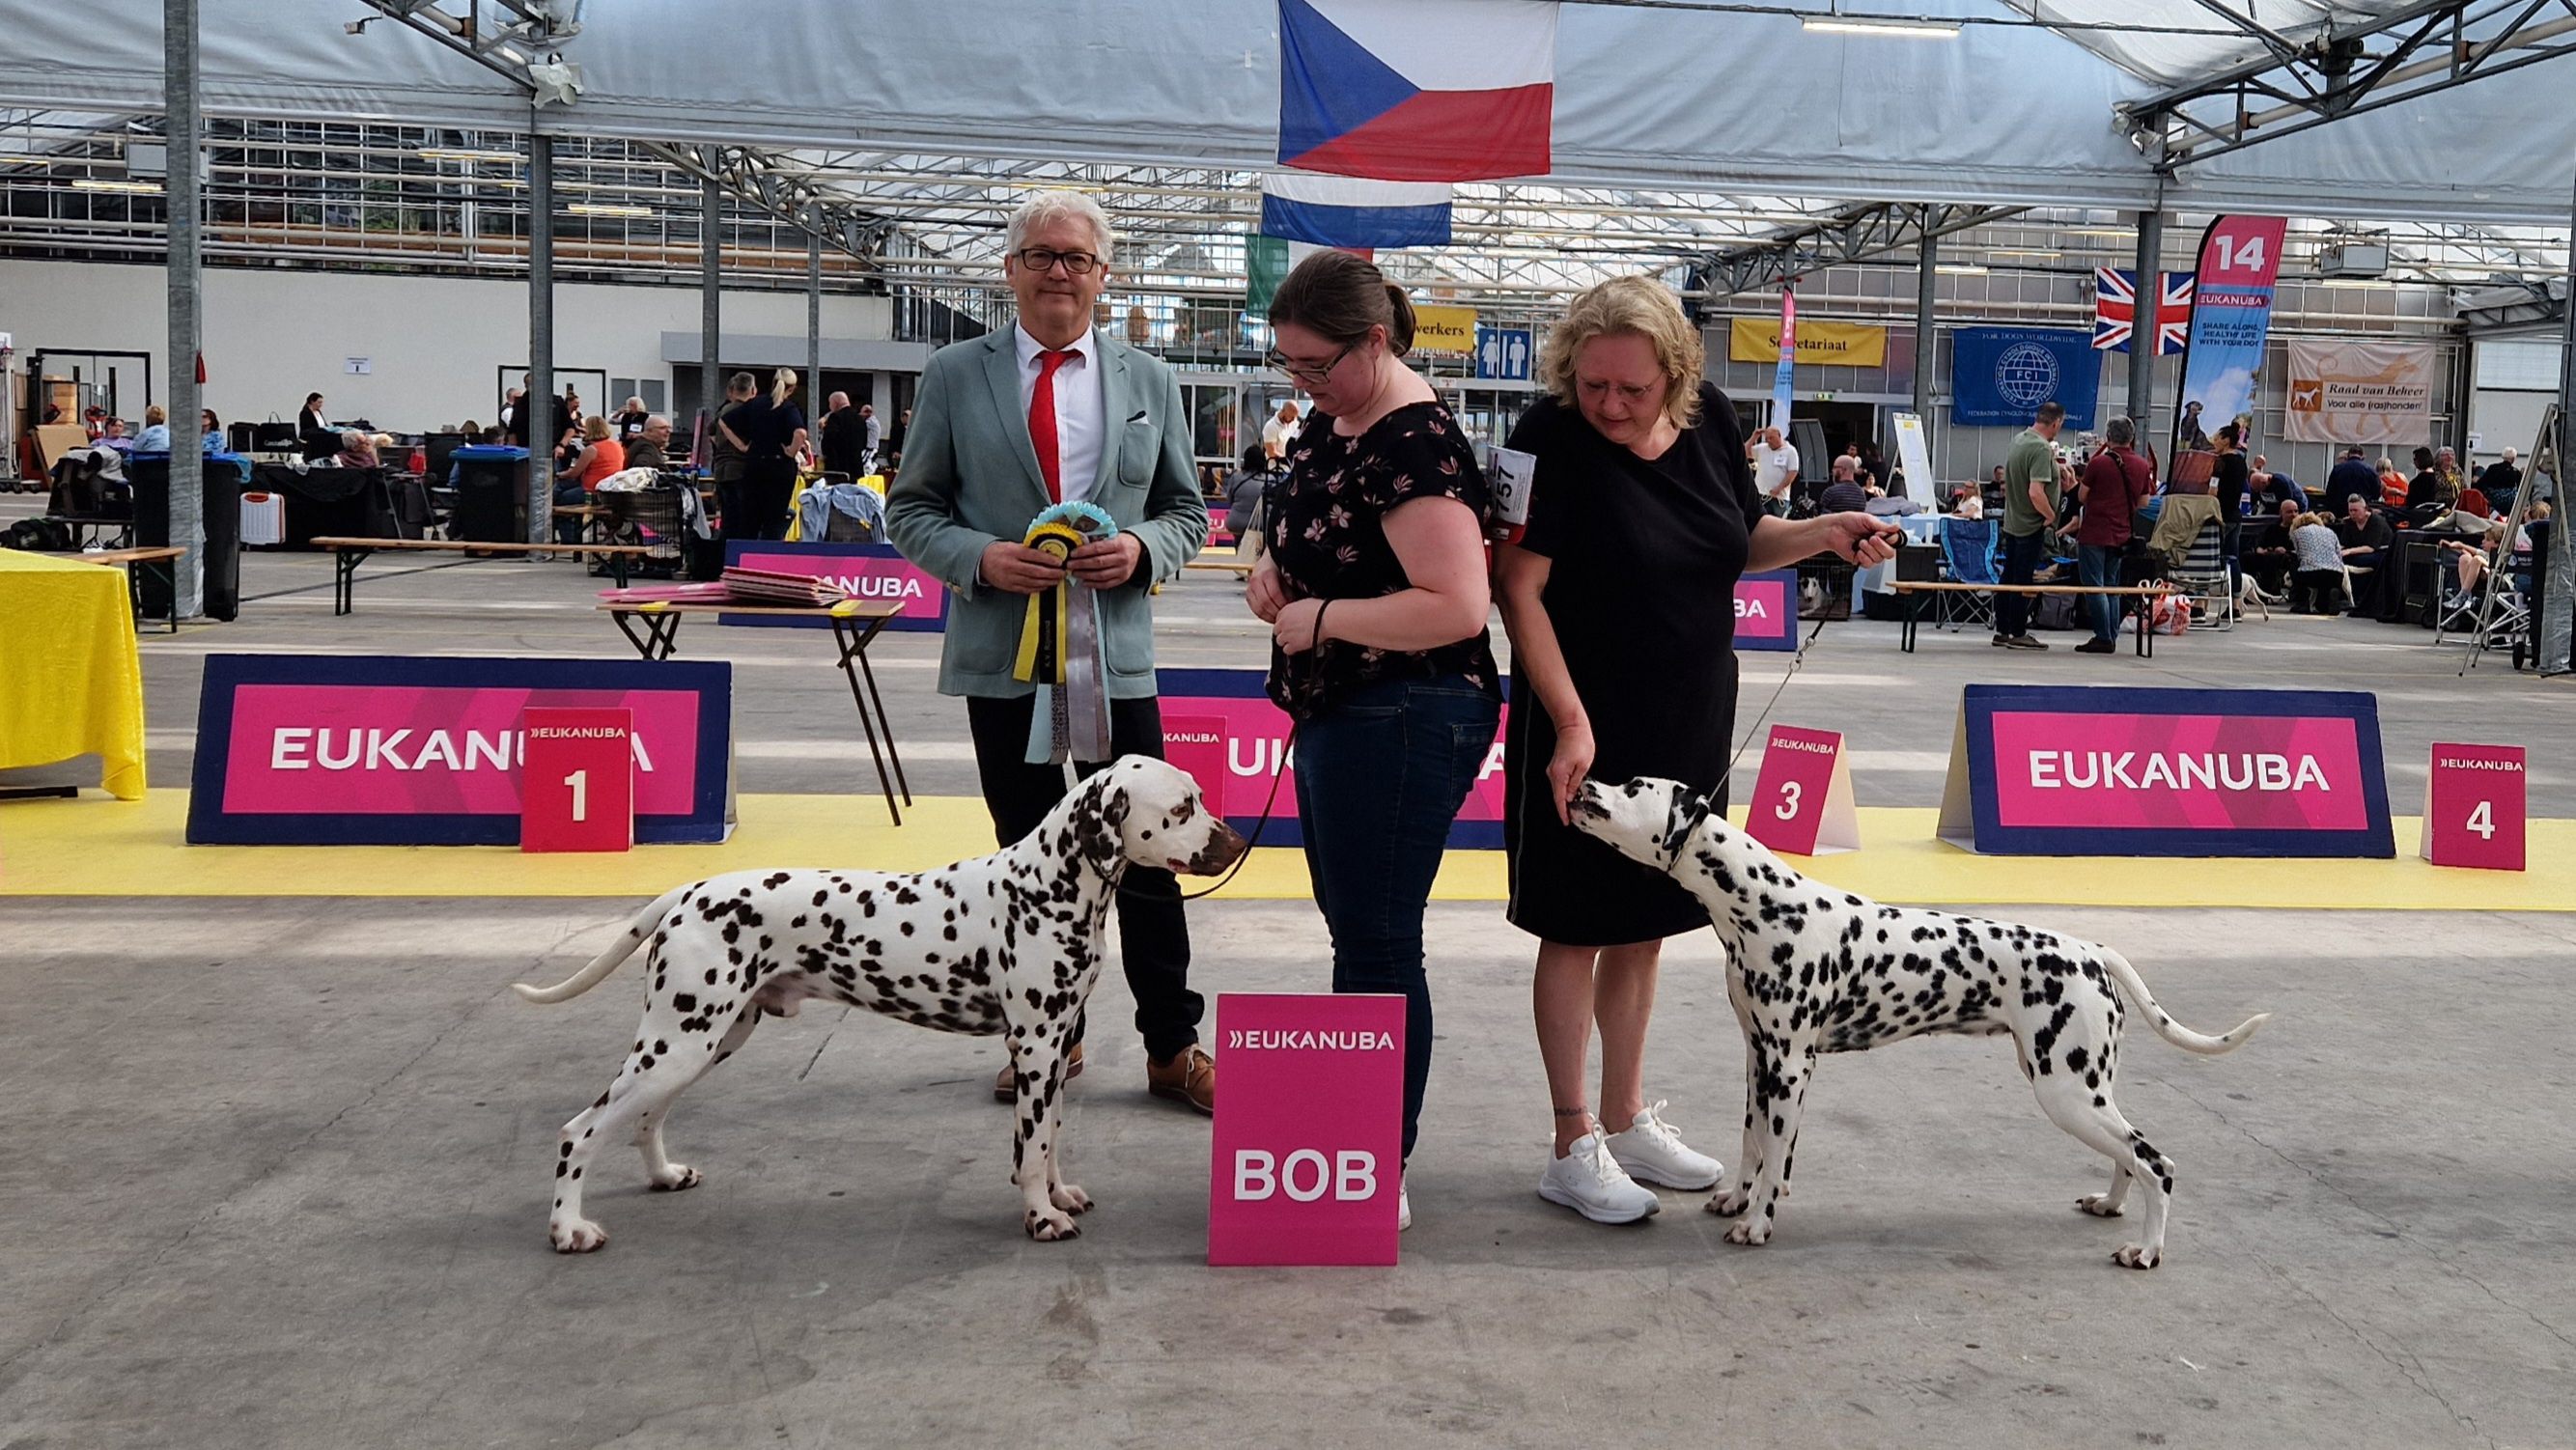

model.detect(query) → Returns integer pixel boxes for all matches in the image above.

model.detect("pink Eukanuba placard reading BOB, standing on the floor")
[1208,991,1404,1268]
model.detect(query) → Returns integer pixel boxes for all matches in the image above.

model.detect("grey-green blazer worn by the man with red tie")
[886,327,1208,701]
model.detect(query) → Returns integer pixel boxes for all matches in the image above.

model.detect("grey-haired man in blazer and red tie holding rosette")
[886,190,1216,1113]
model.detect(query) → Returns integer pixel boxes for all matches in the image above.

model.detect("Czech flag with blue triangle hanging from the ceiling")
[1280,0,1555,181]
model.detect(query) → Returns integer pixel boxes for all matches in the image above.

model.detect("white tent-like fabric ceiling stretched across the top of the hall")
[0,0,2576,224]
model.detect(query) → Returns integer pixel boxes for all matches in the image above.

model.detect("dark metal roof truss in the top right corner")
[2113,0,2576,175]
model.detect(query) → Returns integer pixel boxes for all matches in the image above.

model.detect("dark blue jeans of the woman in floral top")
[1296,675,1501,1157]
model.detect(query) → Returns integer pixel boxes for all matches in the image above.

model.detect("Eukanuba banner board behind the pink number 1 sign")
[188,655,734,845]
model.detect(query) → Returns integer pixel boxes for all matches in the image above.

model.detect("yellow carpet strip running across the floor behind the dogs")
[0,791,2576,911]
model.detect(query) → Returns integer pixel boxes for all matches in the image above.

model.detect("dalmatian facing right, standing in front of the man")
[518,755,1245,1254]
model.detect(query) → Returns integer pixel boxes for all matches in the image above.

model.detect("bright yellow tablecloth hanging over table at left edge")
[0,548,144,801]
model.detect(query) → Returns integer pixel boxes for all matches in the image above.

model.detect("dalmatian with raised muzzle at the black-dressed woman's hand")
[1571,780,2270,1269]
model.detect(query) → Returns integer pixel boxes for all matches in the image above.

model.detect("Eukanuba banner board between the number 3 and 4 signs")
[1940,685,2395,857]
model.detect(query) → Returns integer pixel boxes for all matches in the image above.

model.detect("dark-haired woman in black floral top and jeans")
[1245,252,1501,1223]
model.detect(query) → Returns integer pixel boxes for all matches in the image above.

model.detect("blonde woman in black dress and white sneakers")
[1497,278,1890,1223]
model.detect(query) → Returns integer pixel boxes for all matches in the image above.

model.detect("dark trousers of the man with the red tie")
[966,695,1206,1061]
